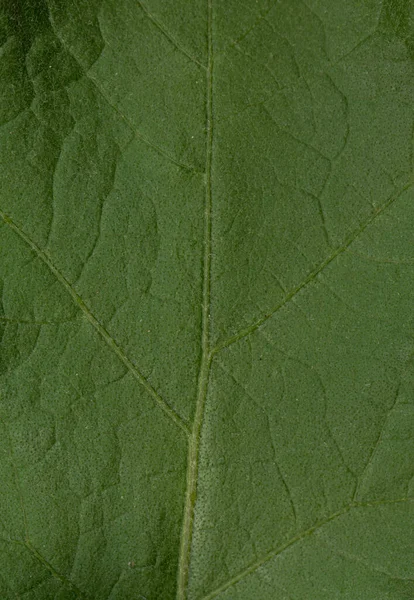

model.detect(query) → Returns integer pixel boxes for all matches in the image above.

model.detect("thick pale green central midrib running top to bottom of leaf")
[177,0,213,600]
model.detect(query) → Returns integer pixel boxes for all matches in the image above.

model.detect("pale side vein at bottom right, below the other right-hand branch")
[201,498,414,600]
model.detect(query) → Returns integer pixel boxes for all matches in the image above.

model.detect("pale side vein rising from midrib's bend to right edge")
[211,181,414,355]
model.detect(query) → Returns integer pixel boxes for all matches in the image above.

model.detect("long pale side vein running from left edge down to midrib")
[0,211,190,435]
